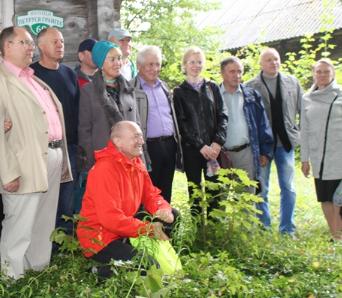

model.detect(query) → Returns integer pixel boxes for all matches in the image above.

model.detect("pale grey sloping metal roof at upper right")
[198,0,342,49]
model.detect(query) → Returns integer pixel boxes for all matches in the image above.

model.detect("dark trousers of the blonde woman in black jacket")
[183,145,219,216]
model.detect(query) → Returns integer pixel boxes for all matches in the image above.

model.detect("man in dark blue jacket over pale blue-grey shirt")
[220,56,273,193]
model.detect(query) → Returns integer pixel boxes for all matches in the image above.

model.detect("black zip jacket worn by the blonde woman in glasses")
[174,81,228,150]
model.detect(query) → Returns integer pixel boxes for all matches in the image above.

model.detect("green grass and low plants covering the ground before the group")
[0,164,342,298]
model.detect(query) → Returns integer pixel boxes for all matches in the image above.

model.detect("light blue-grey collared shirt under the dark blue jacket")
[220,84,249,149]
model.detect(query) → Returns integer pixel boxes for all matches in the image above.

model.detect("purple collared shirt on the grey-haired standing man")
[139,76,174,138]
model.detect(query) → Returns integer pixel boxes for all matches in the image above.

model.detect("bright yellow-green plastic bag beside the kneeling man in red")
[129,236,183,275]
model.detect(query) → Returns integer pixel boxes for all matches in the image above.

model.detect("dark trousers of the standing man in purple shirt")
[146,137,177,203]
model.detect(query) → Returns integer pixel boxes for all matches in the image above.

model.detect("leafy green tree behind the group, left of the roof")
[121,0,222,87]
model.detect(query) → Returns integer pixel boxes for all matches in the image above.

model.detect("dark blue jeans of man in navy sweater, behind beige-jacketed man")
[56,145,78,235]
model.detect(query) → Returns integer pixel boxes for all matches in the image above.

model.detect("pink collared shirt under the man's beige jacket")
[4,60,63,141]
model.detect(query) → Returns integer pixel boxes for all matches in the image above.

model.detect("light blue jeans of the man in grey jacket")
[256,146,296,233]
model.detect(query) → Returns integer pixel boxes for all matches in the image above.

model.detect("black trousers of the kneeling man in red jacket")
[90,208,180,278]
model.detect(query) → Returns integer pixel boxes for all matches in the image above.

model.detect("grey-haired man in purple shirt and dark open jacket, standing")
[132,46,182,202]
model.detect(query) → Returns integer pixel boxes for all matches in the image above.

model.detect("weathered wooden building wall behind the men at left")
[0,0,122,63]
